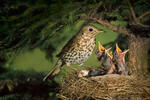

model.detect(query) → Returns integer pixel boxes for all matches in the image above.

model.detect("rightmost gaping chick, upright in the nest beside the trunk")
[113,44,129,75]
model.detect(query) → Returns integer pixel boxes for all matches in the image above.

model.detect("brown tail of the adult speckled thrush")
[43,60,63,81]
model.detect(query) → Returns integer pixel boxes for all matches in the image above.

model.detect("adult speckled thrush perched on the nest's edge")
[43,25,103,81]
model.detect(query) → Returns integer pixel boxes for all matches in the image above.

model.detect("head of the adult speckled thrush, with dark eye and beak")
[81,25,104,36]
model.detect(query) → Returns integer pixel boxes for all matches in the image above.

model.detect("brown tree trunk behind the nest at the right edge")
[128,34,149,73]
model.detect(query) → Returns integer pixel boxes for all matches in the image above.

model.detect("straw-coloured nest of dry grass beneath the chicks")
[58,73,150,100]
